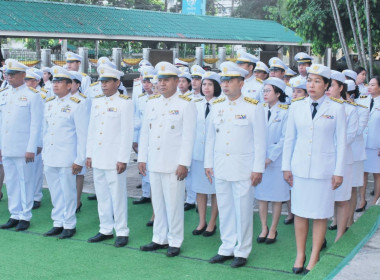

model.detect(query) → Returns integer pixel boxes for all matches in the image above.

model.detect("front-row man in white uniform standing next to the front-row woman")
[204,61,266,267]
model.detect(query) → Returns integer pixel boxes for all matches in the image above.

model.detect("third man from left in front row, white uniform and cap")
[86,66,133,247]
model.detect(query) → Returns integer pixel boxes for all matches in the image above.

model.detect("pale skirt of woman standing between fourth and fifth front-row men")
[190,160,215,194]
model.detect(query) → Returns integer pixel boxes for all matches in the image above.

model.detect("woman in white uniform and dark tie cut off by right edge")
[356,76,380,209]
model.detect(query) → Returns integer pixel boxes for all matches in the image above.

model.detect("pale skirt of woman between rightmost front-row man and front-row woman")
[255,165,290,202]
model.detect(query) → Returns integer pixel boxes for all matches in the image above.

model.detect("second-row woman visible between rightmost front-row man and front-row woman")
[255,77,290,244]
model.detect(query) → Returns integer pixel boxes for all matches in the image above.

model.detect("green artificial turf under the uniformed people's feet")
[0,189,380,280]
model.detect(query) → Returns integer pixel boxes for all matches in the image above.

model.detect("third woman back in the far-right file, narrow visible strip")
[345,80,369,228]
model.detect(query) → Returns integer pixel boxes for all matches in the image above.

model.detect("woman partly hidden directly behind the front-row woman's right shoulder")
[326,71,359,242]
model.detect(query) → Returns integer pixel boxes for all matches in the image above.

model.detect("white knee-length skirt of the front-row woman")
[291,176,334,219]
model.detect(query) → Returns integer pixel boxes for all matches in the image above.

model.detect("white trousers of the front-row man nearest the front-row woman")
[215,178,254,258]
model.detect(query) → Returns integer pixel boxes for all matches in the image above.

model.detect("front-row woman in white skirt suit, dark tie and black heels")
[282,64,346,274]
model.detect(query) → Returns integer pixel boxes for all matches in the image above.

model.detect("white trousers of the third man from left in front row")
[93,168,129,236]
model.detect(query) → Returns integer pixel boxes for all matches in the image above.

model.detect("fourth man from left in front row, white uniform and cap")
[138,62,197,257]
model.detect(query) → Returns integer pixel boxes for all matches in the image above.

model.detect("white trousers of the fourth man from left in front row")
[150,172,185,248]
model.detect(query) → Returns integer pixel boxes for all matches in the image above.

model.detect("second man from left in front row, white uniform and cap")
[42,66,89,239]
